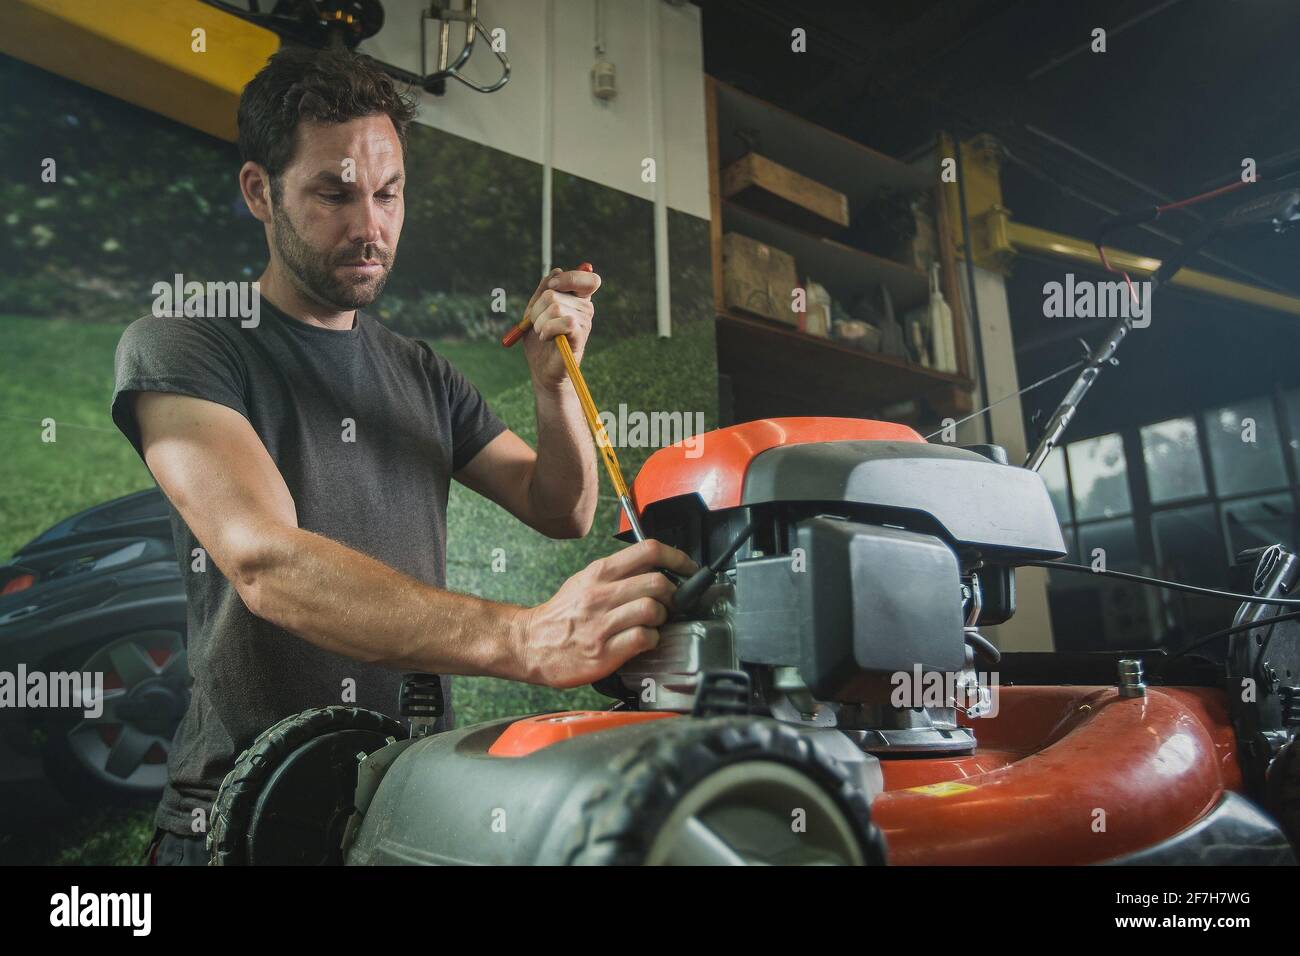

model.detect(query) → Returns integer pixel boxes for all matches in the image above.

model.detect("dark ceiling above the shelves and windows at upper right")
[698,0,1300,437]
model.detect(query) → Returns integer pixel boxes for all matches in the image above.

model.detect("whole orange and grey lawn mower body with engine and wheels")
[209,419,1300,865]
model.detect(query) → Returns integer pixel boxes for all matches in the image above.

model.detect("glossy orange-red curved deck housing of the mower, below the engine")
[872,687,1242,865]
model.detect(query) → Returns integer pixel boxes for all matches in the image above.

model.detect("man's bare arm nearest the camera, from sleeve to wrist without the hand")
[135,393,524,679]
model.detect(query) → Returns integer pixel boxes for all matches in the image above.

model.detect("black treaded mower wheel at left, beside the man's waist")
[208,705,406,866]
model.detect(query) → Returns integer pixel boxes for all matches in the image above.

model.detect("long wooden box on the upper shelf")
[722,152,849,234]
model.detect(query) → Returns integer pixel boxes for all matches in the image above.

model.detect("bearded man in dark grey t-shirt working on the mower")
[113,48,694,862]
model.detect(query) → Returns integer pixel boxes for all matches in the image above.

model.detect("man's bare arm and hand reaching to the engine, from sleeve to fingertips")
[135,392,693,687]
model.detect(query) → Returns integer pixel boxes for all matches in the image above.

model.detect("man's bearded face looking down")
[270,114,406,311]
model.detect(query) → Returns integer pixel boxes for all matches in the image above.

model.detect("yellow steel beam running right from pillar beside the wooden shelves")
[940,137,1300,316]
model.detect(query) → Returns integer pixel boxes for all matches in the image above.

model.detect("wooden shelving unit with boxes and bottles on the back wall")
[705,77,974,427]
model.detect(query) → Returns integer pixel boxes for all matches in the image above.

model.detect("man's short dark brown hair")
[239,47,416,200]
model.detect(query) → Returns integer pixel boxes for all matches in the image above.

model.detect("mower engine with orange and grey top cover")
[597,419,1065,756]
